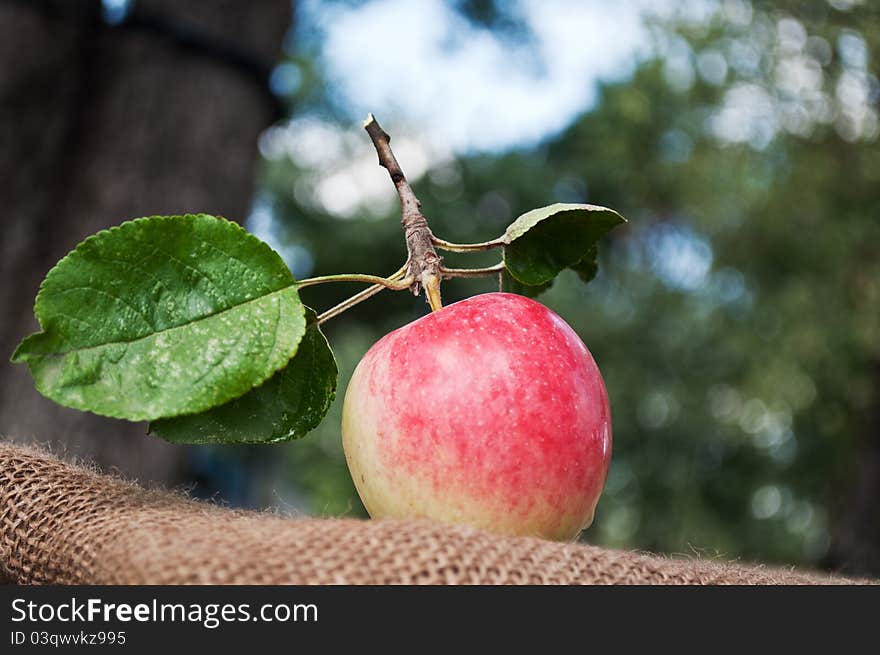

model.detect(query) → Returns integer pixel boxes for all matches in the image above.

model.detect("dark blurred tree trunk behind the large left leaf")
[0,0,291,484]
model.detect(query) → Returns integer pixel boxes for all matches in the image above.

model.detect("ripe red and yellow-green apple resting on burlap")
[342,293,611,540]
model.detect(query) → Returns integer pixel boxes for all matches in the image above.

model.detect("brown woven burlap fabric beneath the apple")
[0,443,868,584]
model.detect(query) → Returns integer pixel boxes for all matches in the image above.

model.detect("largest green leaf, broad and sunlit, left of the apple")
[12,214,305,421]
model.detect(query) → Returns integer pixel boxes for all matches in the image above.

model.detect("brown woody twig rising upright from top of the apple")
[364,114,443,311]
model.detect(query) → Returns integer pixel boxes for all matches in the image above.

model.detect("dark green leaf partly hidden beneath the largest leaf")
[150,308,337,444]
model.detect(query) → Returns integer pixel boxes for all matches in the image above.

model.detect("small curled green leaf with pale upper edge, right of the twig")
[502,203,626,286]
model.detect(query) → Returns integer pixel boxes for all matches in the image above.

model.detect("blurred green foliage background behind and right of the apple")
[246,2,880,572]
